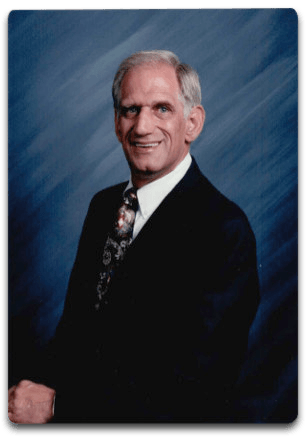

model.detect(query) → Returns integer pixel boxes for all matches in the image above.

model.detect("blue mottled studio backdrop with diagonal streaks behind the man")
[8,8,298,422]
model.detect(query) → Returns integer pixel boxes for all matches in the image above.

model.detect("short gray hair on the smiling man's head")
[112,50,201,118]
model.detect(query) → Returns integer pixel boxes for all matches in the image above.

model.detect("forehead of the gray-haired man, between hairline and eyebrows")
[121,63,180,102]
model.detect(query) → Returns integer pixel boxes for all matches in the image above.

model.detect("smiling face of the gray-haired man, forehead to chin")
[115,64,189,186]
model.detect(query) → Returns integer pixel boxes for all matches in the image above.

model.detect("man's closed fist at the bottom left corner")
[8,380,55,424]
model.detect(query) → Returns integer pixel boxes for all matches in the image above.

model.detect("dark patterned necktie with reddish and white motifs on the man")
[95,188,138,310]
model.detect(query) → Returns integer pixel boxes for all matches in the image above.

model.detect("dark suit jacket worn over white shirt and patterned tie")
[40,159,258,422]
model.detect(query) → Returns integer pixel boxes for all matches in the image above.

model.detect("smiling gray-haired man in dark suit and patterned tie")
[9,51,258,423]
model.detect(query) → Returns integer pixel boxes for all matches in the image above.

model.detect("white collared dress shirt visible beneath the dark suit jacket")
[125,153,192,239]
